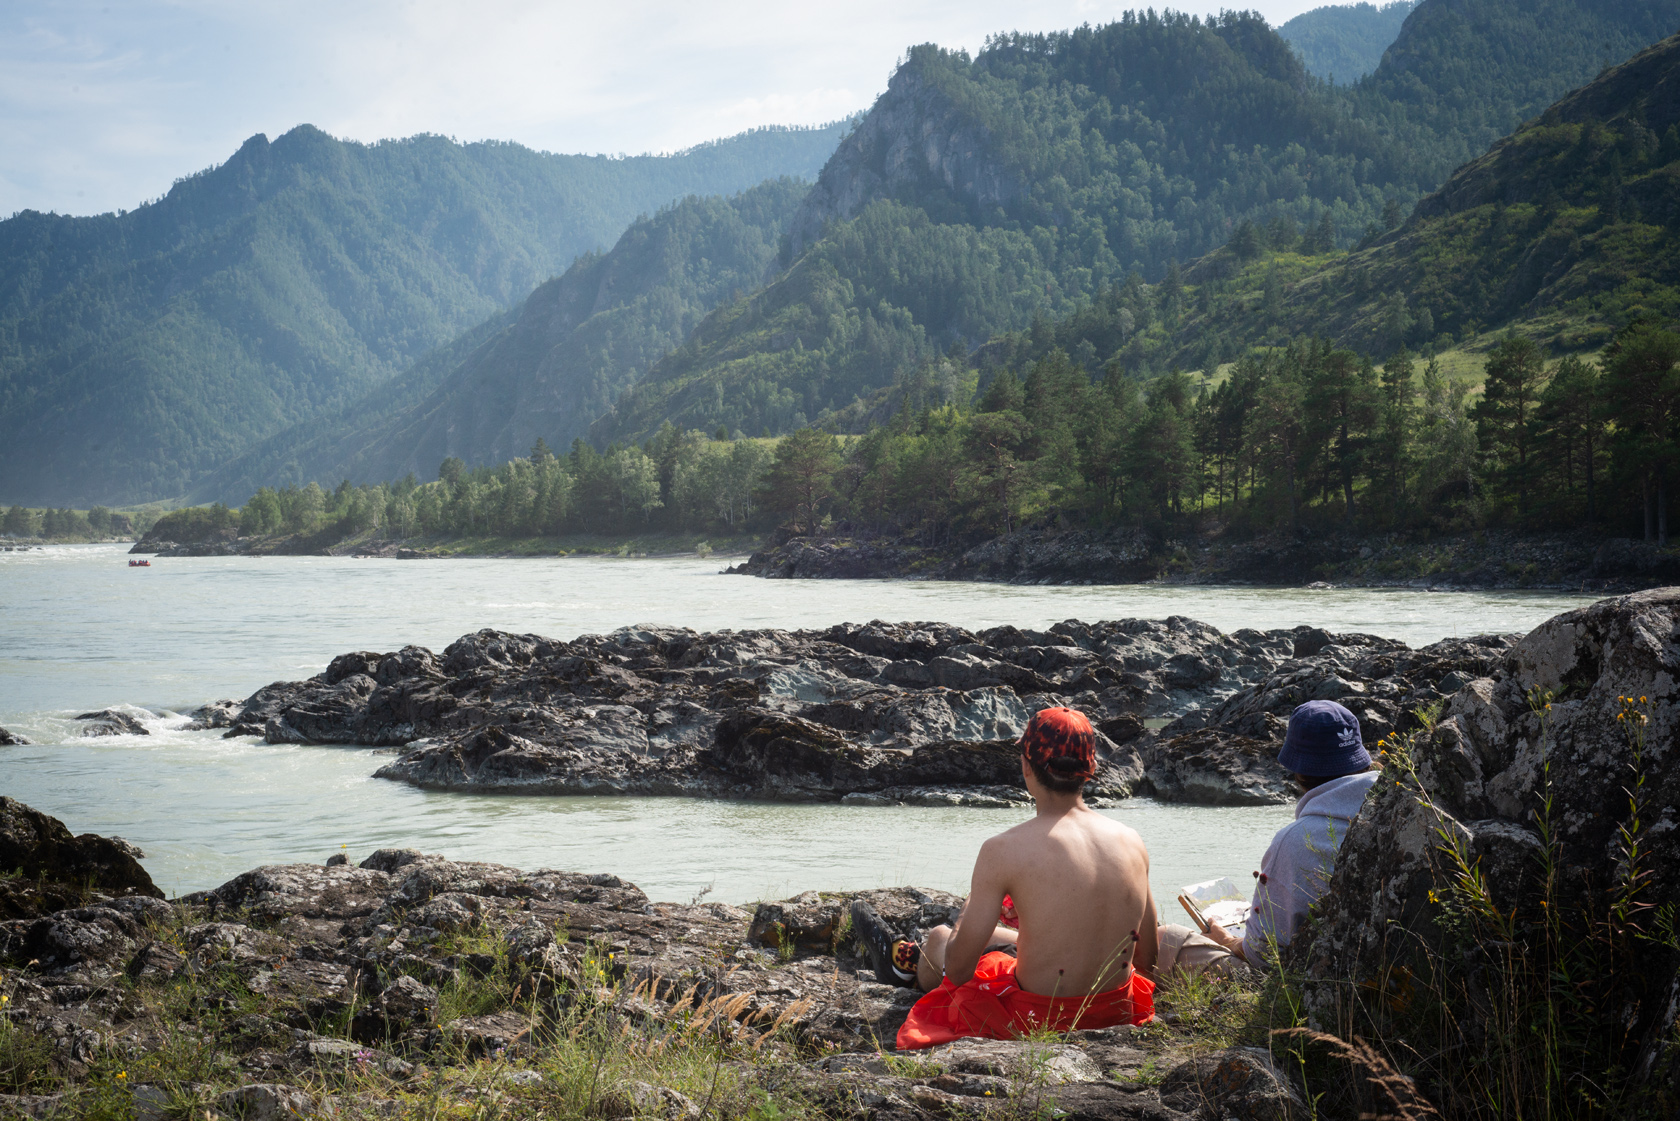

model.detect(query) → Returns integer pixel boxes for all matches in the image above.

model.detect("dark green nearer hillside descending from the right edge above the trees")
[1178,35,1680,365]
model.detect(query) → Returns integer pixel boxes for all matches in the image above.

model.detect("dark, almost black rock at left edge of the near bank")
[0,797,163,919]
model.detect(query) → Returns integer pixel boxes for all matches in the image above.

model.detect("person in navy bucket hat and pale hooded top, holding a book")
[1208,701,1378,968]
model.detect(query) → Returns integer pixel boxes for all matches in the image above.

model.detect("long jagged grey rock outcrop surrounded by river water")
[177,617,1515,807]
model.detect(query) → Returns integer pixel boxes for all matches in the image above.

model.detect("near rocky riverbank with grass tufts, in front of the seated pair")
[0,800,1300,1121]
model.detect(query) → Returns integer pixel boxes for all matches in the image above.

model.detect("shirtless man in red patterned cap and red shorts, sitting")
[853,708,1156,1047]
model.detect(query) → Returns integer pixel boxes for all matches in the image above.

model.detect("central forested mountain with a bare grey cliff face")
[593,13,1418,442]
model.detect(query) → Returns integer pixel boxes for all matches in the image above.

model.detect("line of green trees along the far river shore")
[95,321,1680,584]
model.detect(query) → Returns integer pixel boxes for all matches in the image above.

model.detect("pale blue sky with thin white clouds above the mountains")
[0,0,1324,215]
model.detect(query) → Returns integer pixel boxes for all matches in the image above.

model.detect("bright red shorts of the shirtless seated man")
[899,951,1154,1050]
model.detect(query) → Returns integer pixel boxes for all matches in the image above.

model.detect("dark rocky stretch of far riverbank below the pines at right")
[729,528,1680,595]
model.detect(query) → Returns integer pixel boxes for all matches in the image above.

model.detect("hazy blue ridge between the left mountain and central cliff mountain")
[195,178,808,504]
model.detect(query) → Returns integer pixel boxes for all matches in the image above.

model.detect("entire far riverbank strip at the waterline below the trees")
[133,526,1680,595]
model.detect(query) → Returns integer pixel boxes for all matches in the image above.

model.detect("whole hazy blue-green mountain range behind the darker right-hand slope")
[0,0,1680,503]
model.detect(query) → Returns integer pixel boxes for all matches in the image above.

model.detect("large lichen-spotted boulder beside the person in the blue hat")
[1290,588,1680,1104]
